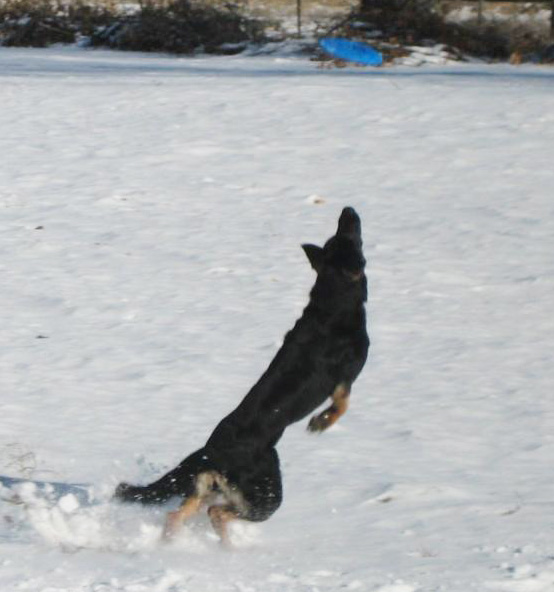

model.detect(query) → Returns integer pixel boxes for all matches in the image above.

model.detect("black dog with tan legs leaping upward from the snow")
[115,208,369,542]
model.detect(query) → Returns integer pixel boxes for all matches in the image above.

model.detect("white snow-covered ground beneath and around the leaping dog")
[0,49,554,592]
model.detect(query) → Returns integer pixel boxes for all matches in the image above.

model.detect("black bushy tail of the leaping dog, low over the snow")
[114,449,211,505]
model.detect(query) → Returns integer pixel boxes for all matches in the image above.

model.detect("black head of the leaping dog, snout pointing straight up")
[302,208,366,294]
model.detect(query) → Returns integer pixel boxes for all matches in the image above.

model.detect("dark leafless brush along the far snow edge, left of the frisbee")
[0,0,264,54]
